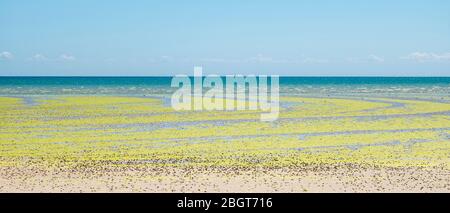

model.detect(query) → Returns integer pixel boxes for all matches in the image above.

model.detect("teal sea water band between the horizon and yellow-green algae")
[0,77,450,97]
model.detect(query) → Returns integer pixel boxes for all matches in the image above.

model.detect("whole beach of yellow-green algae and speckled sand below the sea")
[0,78,450,192]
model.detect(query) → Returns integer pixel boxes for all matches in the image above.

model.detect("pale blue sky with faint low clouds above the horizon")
[0,0,450,76]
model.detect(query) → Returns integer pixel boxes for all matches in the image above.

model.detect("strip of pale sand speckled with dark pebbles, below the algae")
[0,164,450,193]
